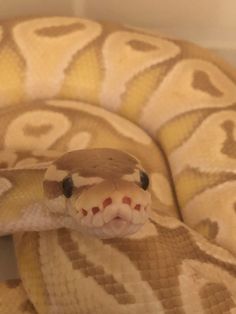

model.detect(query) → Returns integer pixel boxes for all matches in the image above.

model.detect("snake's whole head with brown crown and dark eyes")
[43,148,151,238]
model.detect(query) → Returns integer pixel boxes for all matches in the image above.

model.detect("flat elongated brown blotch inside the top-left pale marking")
[36,22,85,37]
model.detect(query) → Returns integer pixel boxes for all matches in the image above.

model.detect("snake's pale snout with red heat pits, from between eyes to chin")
[71,180,151,237]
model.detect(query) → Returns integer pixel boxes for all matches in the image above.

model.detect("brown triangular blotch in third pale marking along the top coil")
[192,71,223,97]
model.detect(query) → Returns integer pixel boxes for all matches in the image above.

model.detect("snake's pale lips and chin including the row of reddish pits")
[74,190,151,238]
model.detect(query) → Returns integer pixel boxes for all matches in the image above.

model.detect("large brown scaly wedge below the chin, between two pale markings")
[104,224,184,314]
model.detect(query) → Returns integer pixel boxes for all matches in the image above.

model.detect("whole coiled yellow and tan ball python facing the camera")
[0,17,236,314]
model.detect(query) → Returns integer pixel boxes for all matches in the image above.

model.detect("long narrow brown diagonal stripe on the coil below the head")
[57,229,136,304]
